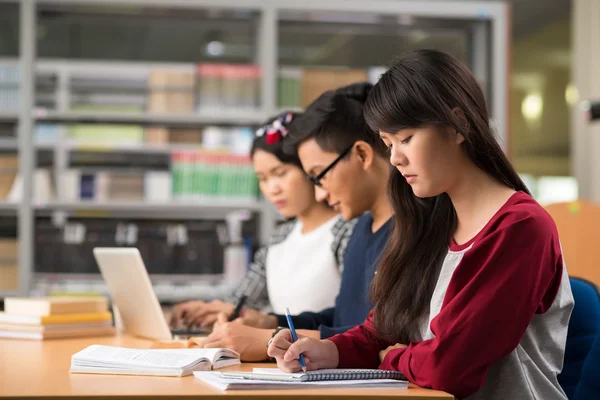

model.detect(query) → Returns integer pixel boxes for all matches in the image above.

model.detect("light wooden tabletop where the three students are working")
[0,336,453,400]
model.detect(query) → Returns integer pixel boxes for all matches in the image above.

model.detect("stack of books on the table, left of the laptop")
[0,297,115,340]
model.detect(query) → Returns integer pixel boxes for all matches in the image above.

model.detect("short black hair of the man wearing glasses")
[284,82,387,157]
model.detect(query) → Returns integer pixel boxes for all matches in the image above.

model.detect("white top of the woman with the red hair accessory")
[266,216,342,315]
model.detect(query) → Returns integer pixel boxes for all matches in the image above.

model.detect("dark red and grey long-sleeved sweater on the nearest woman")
[330,192,573,398]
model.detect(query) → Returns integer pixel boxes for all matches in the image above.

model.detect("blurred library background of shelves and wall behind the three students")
[0,0,600,303]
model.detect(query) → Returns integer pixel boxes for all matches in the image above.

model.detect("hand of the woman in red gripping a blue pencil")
[267,329,340,372]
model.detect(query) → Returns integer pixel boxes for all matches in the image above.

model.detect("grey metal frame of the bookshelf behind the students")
[0,0,509,297]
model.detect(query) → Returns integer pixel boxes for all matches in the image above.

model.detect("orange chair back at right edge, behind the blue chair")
[545,200,600,286]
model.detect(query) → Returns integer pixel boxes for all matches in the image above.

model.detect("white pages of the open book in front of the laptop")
[73,345,218,368]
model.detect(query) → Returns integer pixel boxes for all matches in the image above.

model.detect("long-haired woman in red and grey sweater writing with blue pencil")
[268,50,573,400]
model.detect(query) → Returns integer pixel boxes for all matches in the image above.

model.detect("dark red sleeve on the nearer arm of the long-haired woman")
[380,217,567,398]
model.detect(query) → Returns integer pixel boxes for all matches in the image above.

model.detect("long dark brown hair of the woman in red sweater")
[365,50,529,343]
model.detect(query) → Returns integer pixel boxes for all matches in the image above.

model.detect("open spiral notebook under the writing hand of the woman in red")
[194,368,408,390]
